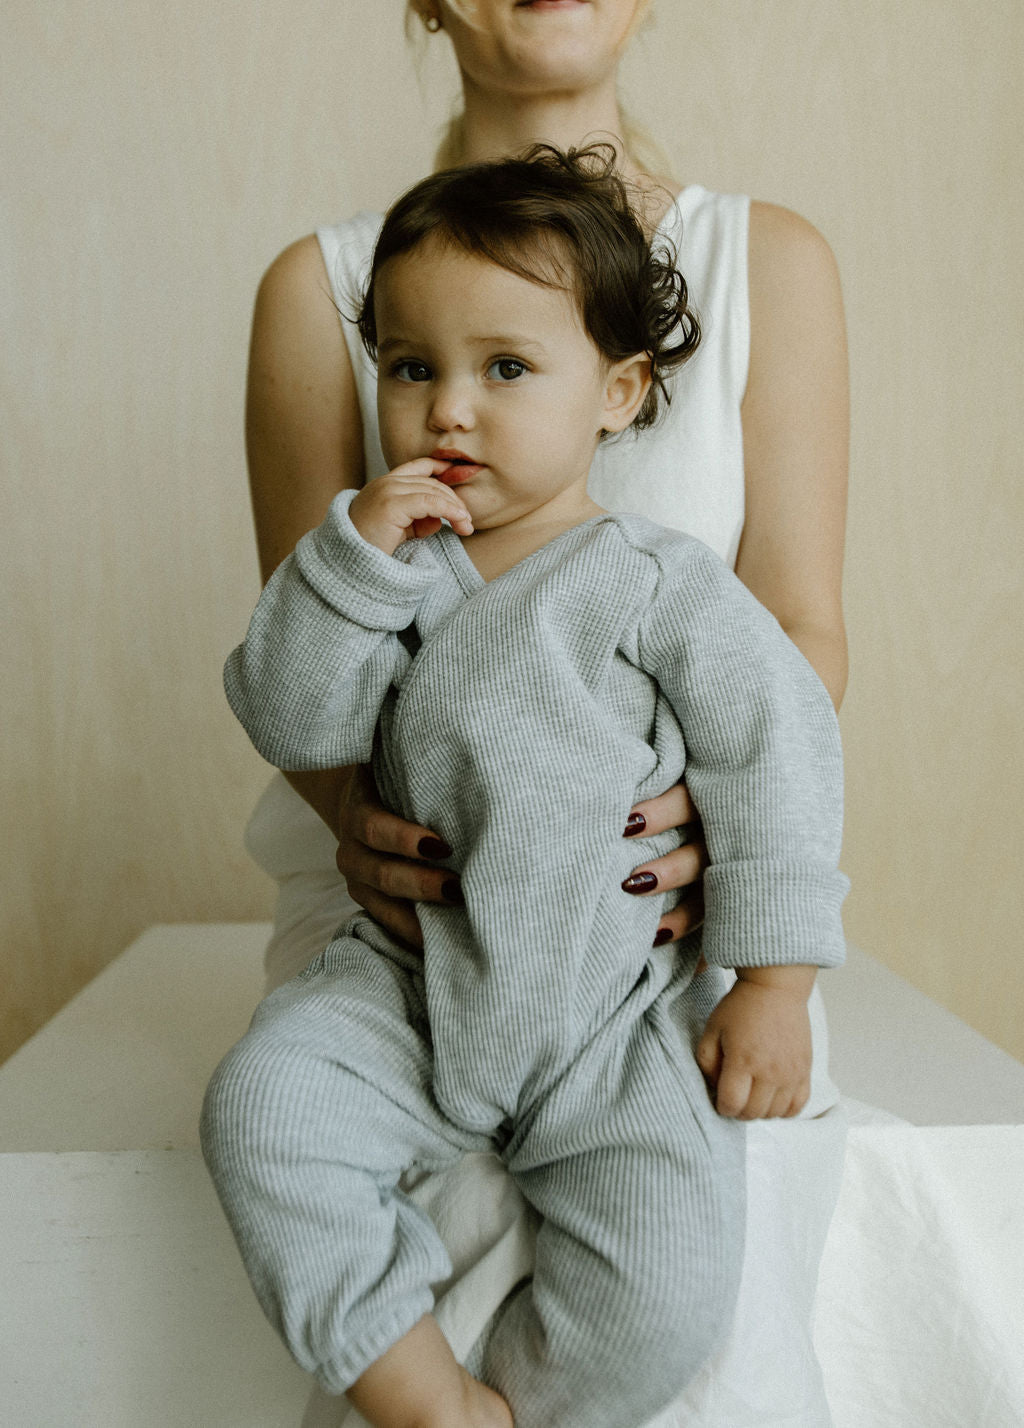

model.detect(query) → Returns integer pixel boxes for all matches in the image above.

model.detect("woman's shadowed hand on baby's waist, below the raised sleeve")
[337,767,463,947]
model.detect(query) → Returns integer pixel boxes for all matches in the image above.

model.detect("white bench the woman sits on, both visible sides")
[0,924,1024,1428]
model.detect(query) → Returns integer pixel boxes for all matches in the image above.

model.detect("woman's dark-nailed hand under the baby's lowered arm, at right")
[623,784,707,947]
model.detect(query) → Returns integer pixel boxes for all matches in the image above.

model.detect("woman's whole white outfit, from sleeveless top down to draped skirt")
[247,186,845,1428]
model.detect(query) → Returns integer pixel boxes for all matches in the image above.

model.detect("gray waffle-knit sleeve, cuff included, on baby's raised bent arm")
[224,491,437,770]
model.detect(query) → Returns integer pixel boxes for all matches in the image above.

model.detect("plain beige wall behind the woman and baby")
[0,0,1024,1057]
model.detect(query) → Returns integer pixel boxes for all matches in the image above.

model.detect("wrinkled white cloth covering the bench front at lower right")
[816,1125,1024,1428]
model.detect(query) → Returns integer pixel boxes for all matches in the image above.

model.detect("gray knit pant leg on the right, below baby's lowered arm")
[483,998,744,1428]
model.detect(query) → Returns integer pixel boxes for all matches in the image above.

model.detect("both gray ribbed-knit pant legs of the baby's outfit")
[201,917,744,1428]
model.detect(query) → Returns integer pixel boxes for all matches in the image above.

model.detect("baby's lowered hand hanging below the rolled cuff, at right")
[697,967,815,1121]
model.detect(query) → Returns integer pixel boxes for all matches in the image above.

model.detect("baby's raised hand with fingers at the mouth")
[348,456,473,555]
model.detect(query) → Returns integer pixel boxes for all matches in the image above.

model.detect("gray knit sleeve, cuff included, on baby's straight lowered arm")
[640,541,848,967]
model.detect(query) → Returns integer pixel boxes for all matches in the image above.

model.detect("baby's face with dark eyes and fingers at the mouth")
[374,241,617,530]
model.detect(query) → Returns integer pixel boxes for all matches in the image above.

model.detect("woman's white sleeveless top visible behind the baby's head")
[317,184,750,565]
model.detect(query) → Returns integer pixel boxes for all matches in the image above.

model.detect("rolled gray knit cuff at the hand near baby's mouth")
[296,491,437,630]
